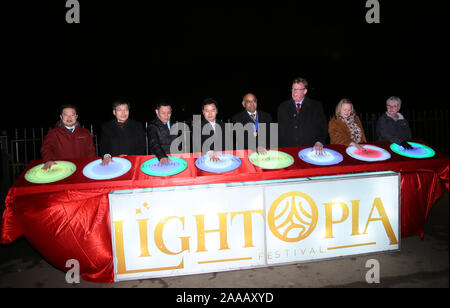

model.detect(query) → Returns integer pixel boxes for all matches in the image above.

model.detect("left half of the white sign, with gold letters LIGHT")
[109,186,265,279]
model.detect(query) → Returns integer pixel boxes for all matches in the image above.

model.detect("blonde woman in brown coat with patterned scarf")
[328,98,367,150]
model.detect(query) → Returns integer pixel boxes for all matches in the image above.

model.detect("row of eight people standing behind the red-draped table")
[41,78,411,169]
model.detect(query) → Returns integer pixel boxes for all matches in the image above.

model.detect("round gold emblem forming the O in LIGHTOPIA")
[267,191,319,243]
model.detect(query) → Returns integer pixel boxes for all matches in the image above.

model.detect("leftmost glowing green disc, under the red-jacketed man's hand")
[25,160,77,184]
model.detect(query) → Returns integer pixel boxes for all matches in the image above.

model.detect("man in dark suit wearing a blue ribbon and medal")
[231,93,272,152]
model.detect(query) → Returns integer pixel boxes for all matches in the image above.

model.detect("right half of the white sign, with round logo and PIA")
[265,176,399,265]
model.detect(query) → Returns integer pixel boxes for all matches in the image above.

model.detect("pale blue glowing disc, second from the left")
[83,157,131,180]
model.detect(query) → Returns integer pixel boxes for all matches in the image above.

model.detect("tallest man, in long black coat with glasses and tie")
[277,78,328,154]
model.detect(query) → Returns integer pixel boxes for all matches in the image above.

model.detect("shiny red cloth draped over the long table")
[0,142,449,282]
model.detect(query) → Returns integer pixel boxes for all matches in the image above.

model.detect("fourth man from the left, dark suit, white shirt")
[201,98,225,161]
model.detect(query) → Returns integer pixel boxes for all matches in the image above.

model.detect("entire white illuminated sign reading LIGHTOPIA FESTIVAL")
[109,172,400,281]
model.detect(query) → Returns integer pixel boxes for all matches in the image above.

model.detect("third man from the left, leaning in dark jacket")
[147,100,177,164]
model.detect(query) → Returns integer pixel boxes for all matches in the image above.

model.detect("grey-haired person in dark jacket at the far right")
[376,96,412,149]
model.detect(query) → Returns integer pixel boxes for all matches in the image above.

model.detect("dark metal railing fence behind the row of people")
[0,109,449,199]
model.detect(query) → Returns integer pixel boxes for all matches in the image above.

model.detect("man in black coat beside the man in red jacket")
[100,99,146,164]
